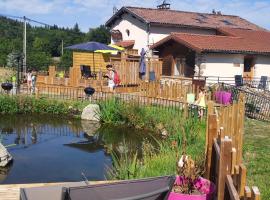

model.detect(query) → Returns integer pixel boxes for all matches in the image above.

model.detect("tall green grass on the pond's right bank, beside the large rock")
[100,99,205,179]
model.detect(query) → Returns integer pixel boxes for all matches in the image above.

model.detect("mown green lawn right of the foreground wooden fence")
[244,119,270,200]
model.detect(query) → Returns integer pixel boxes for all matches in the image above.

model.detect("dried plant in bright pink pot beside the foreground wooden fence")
[168,140,215,200]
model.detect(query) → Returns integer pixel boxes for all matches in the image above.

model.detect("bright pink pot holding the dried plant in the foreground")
[168,176,216,200]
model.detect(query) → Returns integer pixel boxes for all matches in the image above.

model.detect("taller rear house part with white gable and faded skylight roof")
[106,7,262,51]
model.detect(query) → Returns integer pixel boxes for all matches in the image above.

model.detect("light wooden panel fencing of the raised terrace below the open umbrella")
[37,56,162,87]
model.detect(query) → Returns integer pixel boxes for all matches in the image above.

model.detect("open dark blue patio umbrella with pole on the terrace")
[66,42,117,72]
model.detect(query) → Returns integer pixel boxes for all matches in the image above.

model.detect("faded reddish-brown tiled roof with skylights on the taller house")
[106,7,263,30]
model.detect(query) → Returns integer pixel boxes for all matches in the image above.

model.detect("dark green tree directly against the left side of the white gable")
[86,25,110,44]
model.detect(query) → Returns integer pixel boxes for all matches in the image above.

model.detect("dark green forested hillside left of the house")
[0,17,110,69]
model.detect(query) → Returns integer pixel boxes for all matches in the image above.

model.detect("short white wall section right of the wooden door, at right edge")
[254,56,270,78]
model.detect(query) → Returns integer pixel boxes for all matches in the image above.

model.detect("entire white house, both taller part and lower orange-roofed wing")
[106,7,270,79]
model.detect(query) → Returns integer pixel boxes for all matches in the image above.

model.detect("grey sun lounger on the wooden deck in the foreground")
[20,176,175,200]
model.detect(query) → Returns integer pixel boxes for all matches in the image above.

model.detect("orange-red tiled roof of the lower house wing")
[151,28,270,54]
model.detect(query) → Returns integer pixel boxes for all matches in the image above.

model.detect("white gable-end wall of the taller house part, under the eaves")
[111,14,147,52]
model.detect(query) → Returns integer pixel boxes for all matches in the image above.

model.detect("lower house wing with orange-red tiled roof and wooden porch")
[151,28,270,80]
